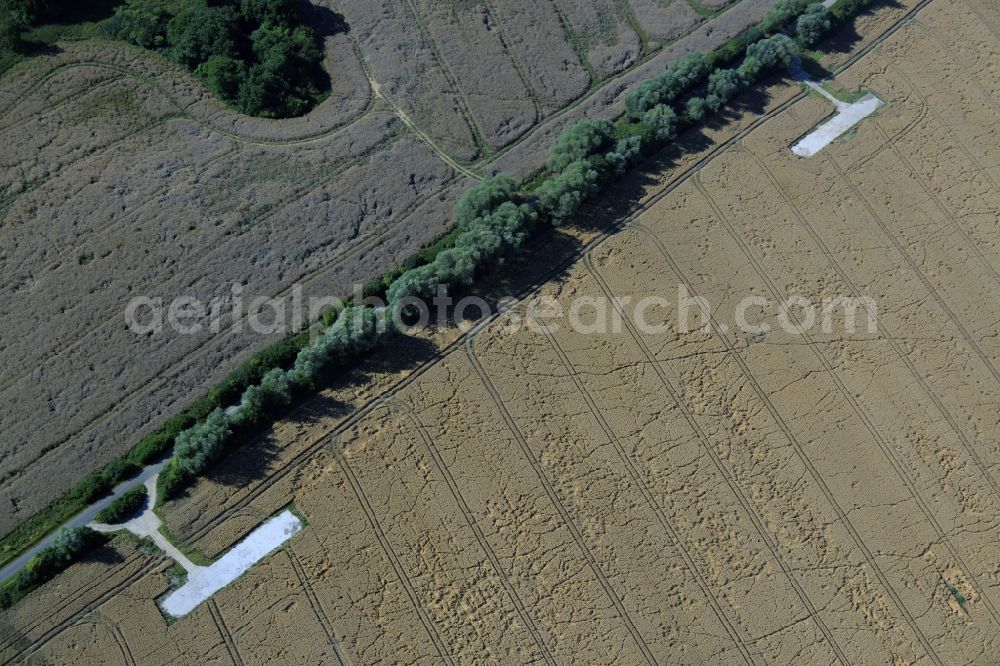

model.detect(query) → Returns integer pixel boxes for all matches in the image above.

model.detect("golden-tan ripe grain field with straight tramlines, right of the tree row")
[0,0,1000,664]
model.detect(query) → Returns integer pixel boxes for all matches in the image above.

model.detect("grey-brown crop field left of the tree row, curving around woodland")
[0,0,774,534]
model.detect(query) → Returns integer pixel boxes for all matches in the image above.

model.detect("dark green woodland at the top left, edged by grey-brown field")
[0,0,330,118]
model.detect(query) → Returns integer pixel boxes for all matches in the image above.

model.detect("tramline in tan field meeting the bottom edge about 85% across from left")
[583,252,850,666]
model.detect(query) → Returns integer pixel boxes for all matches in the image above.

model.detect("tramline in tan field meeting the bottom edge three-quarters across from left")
[540,316,756,664]
